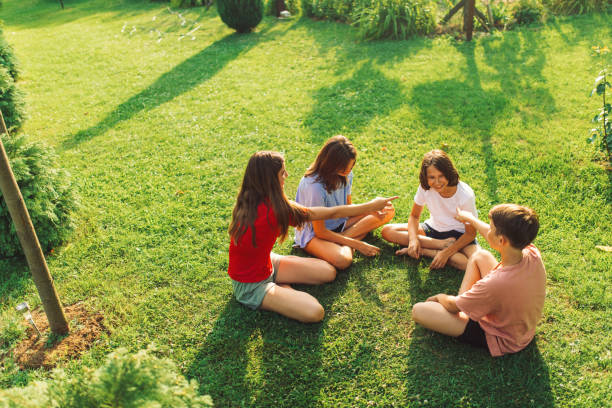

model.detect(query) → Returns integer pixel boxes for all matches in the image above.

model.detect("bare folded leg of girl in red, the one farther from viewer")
[276,255,336,285]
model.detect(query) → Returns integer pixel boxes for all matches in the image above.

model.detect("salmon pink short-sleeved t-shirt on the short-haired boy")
[456,245,546,357]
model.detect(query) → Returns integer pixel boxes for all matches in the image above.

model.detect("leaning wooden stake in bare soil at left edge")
[0,112,70,335]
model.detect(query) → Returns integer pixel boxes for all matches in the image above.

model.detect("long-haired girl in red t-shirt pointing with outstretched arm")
[228,151,397,322]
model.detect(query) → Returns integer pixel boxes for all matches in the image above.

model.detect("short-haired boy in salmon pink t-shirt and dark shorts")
[412,204,546,357]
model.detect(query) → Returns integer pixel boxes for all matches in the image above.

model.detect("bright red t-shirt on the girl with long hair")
[227,202,280,283]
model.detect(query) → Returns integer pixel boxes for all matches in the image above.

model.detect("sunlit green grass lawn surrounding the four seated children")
[0,0,612,407]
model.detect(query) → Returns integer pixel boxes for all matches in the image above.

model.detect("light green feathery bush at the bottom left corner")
[0,349,212,408]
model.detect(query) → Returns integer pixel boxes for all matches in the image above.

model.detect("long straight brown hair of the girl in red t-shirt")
[229,151,309,246]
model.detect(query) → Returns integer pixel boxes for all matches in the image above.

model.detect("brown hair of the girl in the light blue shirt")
[304,135,357,193]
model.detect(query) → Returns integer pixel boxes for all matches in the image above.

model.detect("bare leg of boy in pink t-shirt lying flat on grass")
[412,302,469,337]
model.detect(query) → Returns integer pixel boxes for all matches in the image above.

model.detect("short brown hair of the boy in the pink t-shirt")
[489,204,540,249]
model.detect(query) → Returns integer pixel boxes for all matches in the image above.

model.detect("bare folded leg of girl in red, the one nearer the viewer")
[260,285,325,323]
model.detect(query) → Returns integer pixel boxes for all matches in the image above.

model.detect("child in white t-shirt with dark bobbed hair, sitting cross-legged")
[381,150,478,270]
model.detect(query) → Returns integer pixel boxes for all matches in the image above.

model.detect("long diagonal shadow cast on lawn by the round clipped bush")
[63,29,279,149]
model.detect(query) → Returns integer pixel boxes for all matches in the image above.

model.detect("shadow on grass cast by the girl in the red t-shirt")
[186,264,348,407]
